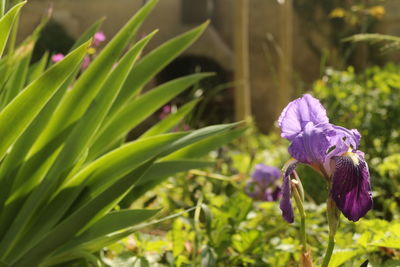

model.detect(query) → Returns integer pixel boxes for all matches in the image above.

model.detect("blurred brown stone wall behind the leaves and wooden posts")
[20,0,400,132]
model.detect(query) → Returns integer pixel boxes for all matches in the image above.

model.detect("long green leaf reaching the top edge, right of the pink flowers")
[0,0,157,253]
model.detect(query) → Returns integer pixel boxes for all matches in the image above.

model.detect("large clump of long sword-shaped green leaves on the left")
[0,0,242,267]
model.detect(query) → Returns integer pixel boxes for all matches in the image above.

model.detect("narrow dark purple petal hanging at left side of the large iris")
[279,161,297,223]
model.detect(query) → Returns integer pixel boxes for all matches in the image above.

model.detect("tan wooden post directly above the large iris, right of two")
[277,0,293,112]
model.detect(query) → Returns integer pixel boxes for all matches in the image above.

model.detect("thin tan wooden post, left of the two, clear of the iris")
[234,0,251,121]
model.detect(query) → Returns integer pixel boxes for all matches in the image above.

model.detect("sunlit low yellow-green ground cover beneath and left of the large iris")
[111,128,400,267]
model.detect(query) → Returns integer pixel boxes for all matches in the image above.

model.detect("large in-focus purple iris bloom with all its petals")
[278,94,373,223]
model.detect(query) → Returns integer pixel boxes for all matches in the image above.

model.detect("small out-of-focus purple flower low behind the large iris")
[245,164,281,201]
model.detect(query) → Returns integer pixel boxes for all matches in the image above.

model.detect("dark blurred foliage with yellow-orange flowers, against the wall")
[293,0,385,69]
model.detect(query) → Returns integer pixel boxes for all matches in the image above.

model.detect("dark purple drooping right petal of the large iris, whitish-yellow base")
[331,151,373,222]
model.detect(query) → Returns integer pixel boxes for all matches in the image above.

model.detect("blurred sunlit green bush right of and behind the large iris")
[313,64,400,220]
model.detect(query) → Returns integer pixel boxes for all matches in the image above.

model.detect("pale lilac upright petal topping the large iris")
[278,94,329,141]
